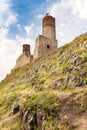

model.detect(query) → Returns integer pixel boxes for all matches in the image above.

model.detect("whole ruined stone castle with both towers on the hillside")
[15,15,57,69]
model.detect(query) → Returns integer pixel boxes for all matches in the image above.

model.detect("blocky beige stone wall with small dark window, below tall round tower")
[34,35,57,59]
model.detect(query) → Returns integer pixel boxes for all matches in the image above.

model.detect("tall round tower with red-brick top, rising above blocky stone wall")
[42,15,56,39]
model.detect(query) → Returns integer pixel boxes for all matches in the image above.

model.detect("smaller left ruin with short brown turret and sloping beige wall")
[14,44,33,69]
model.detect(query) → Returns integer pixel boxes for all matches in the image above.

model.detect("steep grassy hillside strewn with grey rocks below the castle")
[0,33,87,130]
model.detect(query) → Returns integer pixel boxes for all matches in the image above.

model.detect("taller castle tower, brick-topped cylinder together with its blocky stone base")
[34,15,57,59]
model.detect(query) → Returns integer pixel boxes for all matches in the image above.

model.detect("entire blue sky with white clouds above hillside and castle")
[0,0,87,80]
